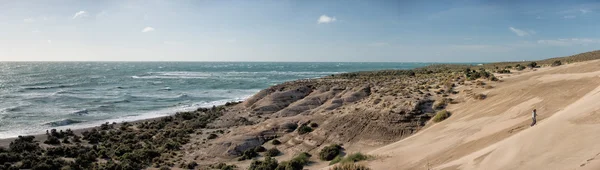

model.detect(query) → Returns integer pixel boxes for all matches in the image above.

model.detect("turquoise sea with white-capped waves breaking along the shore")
[0,62,431,138]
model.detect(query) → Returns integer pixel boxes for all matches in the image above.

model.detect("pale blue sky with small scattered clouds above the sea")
[0,0,600,62]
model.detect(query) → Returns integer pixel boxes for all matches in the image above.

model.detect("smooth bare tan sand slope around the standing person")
[368,61,600,169]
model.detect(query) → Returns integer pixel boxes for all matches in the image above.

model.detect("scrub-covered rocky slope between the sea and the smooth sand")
[0,50,597,169]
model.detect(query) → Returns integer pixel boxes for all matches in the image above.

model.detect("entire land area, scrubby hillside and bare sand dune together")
[0,51,600,169]
